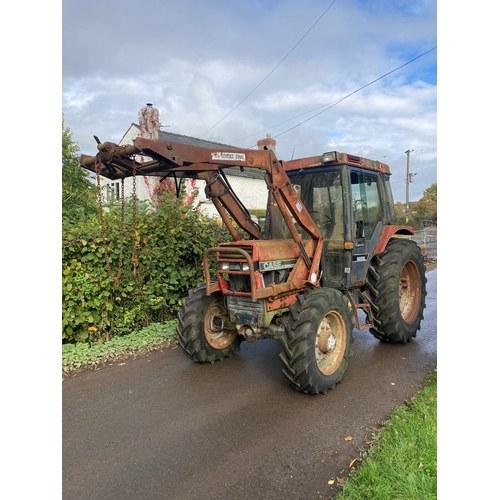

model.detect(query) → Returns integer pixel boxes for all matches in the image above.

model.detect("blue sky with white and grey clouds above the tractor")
[62,0,437,202]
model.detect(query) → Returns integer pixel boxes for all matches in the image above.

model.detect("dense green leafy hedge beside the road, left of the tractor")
[62,194,230,344]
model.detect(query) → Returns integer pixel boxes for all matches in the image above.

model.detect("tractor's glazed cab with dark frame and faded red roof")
[265,152,395,289]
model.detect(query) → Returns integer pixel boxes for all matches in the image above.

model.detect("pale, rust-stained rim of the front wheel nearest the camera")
[315,311,347,375]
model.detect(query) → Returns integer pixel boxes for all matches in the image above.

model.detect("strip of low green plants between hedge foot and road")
[62,320,177,376]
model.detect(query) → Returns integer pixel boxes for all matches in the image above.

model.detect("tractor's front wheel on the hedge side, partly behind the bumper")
[177,285,243,364]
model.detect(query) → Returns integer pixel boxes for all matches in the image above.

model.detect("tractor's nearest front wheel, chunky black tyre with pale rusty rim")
[280,288,352,394]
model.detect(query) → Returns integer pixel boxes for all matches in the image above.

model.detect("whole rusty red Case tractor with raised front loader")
[80,137,426,394]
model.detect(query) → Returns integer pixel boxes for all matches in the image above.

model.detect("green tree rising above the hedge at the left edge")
[62,116,97,221]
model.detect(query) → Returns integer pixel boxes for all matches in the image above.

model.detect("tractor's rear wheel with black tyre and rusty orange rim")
[365,238,427,344]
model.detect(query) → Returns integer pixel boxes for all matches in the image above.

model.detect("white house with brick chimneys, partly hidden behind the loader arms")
[101,105,276,217]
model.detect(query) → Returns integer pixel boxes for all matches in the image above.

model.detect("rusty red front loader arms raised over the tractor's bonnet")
[80,137,323,285]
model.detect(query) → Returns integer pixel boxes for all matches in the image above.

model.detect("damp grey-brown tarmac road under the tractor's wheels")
[62,269,437,500]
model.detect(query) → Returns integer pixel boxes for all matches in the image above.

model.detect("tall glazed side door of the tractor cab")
[349,168,382,285]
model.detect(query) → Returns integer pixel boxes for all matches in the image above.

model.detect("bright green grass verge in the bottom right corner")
[335,372,437,500]
